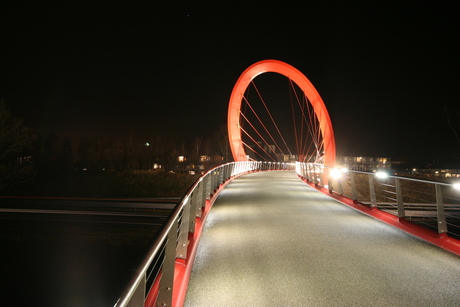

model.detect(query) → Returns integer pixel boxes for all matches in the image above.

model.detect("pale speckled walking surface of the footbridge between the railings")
[185,171,460,307]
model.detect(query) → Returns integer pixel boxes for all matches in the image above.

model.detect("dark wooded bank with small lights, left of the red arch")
[0,100,230,197]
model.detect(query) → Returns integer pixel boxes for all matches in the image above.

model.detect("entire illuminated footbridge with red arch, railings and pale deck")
[117,60,460,307]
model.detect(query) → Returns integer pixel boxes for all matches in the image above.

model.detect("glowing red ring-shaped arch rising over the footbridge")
[227,60,336,166]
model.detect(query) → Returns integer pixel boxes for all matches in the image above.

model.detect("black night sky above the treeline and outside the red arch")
[0,0,460,165]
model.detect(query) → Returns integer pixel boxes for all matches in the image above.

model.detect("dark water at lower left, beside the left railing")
[0,217,158,306]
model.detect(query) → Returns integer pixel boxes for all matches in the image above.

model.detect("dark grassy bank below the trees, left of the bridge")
[2,171,197,198]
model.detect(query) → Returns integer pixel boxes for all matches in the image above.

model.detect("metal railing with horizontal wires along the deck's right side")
[296,162,460,238]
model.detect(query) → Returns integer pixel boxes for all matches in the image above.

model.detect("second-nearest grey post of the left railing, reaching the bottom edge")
[157,220,178,306]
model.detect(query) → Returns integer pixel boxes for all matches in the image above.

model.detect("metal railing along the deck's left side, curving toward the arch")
[115,161,295,307]
